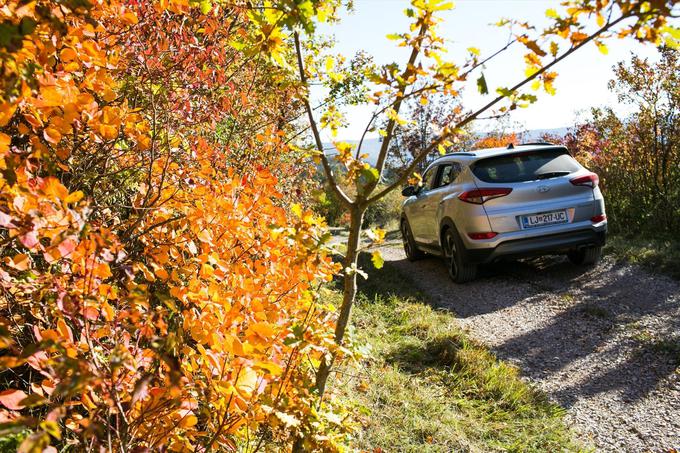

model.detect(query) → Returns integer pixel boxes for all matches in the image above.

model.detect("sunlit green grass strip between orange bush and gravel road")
[329,252,583,453]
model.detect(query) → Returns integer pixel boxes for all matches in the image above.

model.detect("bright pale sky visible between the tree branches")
[320,0,658,141]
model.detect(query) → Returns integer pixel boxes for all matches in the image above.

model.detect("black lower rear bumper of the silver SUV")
[465,227,607,264]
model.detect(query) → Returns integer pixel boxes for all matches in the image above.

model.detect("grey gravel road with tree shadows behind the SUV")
[383,246,680,452]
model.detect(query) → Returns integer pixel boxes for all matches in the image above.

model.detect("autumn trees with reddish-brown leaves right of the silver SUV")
[565,47,680,233]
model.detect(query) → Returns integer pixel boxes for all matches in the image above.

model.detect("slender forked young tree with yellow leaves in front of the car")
[295,0,677,394]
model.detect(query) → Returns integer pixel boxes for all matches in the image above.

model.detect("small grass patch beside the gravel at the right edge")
[605,235,680,280]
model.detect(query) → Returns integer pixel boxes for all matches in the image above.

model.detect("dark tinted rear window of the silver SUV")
[472,148,579,183]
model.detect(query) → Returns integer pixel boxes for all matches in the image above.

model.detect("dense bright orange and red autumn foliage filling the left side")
[0,0,344,451]
